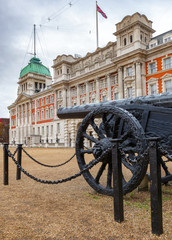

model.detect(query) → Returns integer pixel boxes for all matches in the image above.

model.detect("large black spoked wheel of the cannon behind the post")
[76,106,148,195]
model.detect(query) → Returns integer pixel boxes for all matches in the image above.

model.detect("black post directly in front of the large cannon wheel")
[111,139,124,222]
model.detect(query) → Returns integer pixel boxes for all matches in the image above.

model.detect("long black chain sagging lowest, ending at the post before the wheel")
[7,148,112,184]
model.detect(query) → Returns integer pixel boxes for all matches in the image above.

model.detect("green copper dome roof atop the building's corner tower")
[20,57,51,78]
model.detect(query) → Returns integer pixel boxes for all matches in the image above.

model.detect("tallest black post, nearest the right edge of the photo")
[149,138,163,236]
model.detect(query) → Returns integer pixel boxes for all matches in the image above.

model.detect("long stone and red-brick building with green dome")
[8,13,172,147]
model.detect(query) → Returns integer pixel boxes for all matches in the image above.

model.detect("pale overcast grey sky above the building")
[0,0,172,118]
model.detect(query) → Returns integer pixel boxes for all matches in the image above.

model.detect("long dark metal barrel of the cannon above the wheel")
[57,93,172,119]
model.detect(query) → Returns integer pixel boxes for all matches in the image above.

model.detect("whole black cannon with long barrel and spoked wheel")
[57,93,172,195]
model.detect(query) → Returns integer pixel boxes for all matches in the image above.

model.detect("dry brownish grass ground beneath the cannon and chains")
[0,148,172,240]
